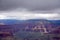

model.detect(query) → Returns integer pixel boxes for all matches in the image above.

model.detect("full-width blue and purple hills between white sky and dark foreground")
[0,19,60,33]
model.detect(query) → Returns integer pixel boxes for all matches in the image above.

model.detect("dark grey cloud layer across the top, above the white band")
[0,0,60,11]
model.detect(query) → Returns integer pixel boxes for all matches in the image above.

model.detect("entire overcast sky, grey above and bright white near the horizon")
[0,0,60,19]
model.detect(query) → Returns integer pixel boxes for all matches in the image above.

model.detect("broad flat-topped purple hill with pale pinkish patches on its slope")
[14,20,58,33]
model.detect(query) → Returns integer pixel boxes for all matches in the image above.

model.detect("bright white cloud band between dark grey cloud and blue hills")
[0,12,60,20]
